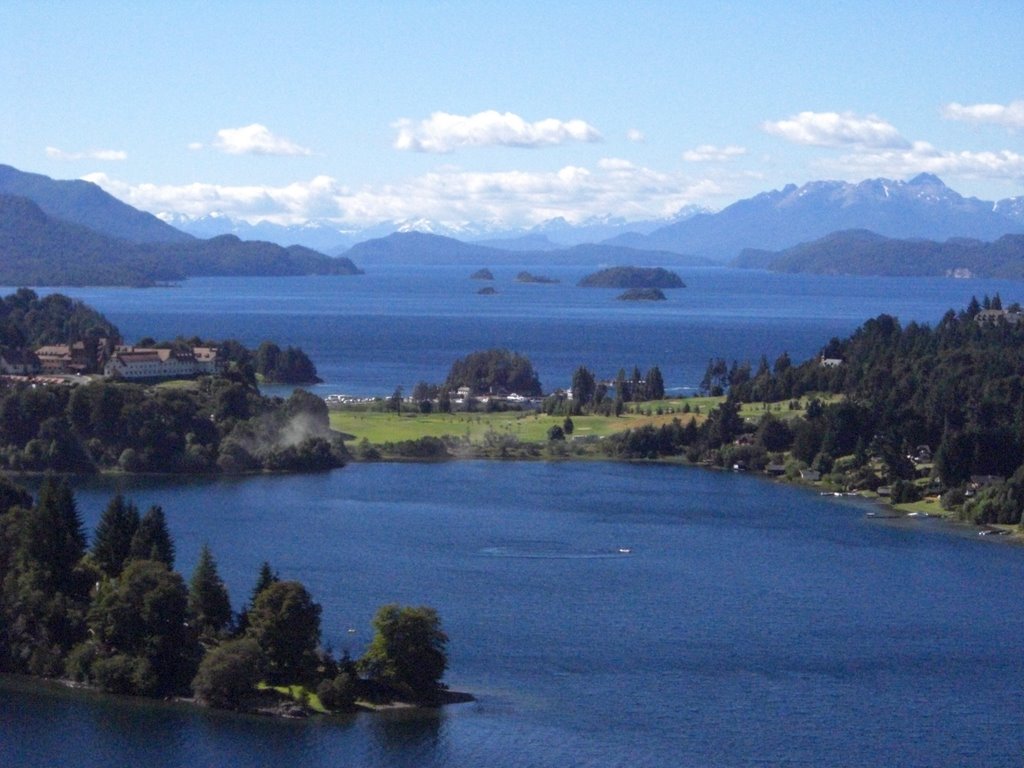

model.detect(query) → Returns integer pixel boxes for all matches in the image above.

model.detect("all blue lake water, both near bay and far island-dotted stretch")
[0,267,1024,767]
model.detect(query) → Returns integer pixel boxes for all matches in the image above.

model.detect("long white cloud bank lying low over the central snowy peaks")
[86,159,744,227]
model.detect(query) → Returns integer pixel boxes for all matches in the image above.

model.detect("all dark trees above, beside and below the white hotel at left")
[0,289,348,473]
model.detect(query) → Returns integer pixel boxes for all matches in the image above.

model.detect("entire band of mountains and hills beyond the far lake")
[0,165,1024,285]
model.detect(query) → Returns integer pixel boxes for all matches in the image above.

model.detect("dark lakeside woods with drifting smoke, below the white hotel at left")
[0,382,347,474]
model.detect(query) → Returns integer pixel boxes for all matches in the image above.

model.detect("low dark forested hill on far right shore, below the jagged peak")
[736,229,1024,280]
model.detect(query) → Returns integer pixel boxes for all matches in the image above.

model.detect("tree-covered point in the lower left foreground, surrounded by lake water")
[0,476,447,712]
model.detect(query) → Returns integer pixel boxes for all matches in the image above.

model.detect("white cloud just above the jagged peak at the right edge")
[829,141,1024,181]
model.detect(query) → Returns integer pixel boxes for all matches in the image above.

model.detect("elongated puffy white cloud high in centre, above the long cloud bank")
[393,110,601,153]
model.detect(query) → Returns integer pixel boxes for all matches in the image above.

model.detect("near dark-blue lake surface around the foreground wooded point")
[0,462,1024,766]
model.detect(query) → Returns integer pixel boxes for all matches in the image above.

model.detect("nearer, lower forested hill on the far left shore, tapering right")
[0,195,359,286]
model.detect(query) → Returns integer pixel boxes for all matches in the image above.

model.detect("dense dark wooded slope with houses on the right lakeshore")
[605,296,1024,523]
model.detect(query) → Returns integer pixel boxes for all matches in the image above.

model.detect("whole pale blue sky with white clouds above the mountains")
[0,0,1024,228]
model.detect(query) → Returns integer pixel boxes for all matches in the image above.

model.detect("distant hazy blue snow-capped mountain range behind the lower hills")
[162,173,1024,263]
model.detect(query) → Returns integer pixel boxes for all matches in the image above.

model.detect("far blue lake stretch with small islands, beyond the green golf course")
[12,266,1024,395]
